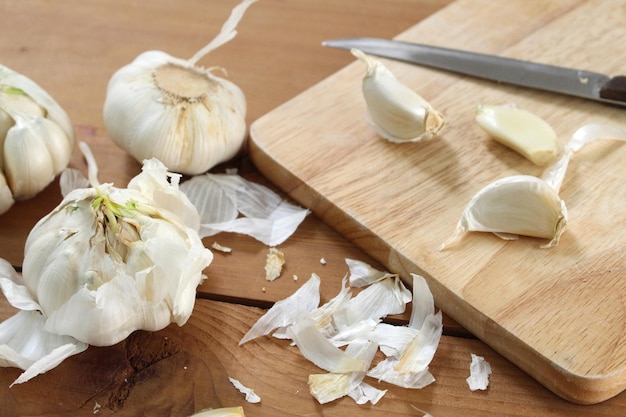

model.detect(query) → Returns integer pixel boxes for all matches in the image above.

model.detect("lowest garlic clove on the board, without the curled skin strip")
[441,175,567,249]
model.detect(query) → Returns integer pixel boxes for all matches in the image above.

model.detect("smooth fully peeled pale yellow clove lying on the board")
[476,105,559,166]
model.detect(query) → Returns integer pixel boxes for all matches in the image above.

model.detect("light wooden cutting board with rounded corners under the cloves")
[250,0,626,404]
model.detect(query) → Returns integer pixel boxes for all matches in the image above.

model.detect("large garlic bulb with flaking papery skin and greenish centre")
[0,143,213,383]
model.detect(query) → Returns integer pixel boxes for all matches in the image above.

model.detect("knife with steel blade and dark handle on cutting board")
[322,38,626,107]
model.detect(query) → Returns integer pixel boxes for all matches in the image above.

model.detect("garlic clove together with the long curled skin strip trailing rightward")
[440,124,626,250]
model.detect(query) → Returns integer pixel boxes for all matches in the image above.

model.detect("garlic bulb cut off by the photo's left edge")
[0,65,75,214]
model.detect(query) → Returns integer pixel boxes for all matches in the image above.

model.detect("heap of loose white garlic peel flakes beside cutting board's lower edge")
[239,259,443,404]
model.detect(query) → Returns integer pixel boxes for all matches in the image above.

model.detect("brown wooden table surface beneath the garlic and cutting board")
[0,0,626,417]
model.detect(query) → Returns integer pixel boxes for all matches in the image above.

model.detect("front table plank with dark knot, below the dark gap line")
[0,300,626,417]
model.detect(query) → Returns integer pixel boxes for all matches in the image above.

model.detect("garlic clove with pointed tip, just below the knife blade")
[350,49,445,143]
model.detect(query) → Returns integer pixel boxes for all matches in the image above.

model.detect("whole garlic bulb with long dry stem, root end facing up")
[103,0,255,175]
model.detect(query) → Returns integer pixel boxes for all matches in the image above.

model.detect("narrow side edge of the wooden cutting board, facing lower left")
[248,120,626,405]
